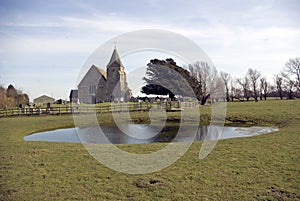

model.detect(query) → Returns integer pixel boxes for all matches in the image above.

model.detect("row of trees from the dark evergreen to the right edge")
[141,58,300,105]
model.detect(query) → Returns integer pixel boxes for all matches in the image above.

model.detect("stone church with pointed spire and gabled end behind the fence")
[78,48,131,103]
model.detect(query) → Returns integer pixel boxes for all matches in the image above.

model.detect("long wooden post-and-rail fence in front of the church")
[0,102,198,117]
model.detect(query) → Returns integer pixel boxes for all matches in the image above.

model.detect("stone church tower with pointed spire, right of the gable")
[106,47,129,101]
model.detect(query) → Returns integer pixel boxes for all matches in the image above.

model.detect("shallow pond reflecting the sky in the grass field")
[24,124,278,144]
